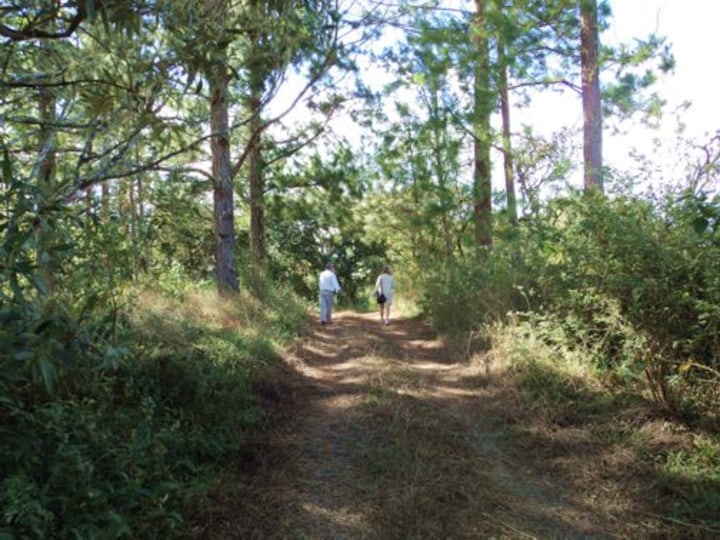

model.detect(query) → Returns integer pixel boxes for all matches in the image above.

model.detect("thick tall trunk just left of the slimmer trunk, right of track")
[472,0,493,248]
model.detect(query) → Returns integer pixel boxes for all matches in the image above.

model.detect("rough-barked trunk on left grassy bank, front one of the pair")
[209,62,240,296]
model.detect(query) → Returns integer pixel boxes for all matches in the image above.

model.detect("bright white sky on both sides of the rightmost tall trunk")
[506,0,720,190]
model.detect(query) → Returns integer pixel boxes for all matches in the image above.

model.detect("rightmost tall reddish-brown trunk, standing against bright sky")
[579,0,604,191]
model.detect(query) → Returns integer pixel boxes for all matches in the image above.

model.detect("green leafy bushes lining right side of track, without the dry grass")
[424,193,720,425]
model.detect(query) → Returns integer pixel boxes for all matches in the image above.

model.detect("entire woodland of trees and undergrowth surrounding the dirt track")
[0,0,720,537]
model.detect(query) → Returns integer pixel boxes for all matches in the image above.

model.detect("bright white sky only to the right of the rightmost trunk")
[602,0,720,191]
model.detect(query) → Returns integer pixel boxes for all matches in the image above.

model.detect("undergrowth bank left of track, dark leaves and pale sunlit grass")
[0,280,306,539]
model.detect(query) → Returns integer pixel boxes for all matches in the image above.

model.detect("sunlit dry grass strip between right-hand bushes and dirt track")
[485,320,720,538]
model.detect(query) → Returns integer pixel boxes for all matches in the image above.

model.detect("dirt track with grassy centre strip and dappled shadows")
[191,312,717,539]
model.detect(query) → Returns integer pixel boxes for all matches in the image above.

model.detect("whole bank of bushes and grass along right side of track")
[422,191,720,530]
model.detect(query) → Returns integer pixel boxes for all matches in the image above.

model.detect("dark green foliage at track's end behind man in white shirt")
[264,149,388,306]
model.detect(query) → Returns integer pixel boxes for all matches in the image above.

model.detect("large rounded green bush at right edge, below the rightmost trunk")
[516,192,720,420]
